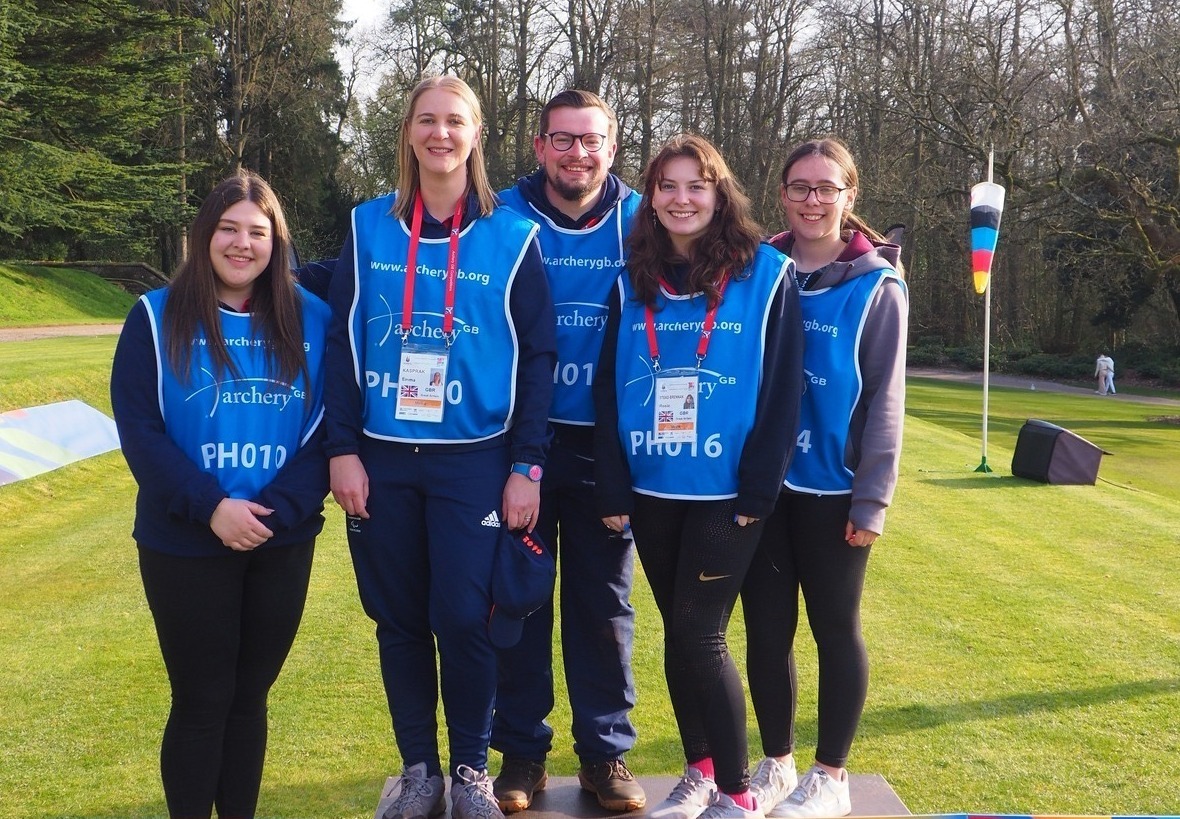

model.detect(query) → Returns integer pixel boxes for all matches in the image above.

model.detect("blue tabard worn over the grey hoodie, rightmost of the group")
[784,268,905,494]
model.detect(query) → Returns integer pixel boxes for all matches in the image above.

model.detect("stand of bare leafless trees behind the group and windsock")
[335,0,1180,349]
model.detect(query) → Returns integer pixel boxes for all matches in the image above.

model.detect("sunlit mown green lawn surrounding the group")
[0,338,1180,819]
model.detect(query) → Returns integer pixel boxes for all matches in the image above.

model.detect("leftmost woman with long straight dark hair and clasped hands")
[111,172,328,819]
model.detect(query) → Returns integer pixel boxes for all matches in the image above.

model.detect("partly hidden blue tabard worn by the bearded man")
[500,186,640,426]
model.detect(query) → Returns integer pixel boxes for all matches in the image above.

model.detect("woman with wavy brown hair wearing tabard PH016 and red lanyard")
[594,136,802,819]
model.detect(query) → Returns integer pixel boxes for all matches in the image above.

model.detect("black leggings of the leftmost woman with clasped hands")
[139,540,315,819]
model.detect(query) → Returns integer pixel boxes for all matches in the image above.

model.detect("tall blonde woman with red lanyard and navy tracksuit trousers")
[326,77,556,819]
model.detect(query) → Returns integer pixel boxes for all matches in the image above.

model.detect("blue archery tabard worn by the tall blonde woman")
[348,194,537,444]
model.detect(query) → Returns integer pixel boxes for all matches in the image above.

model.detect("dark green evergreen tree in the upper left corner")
[0,0,191,257]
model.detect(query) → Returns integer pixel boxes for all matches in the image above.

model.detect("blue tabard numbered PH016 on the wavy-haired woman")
[615,244,787,500]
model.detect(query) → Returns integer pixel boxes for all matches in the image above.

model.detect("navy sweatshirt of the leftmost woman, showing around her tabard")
[111,301,328,557]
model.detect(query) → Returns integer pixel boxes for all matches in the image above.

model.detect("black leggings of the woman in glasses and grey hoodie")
[741,492,871,768]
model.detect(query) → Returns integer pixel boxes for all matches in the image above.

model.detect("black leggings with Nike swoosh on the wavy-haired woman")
[631,494,762,793]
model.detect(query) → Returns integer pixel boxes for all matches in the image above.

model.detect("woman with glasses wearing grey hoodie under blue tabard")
[741,138,909,817]
